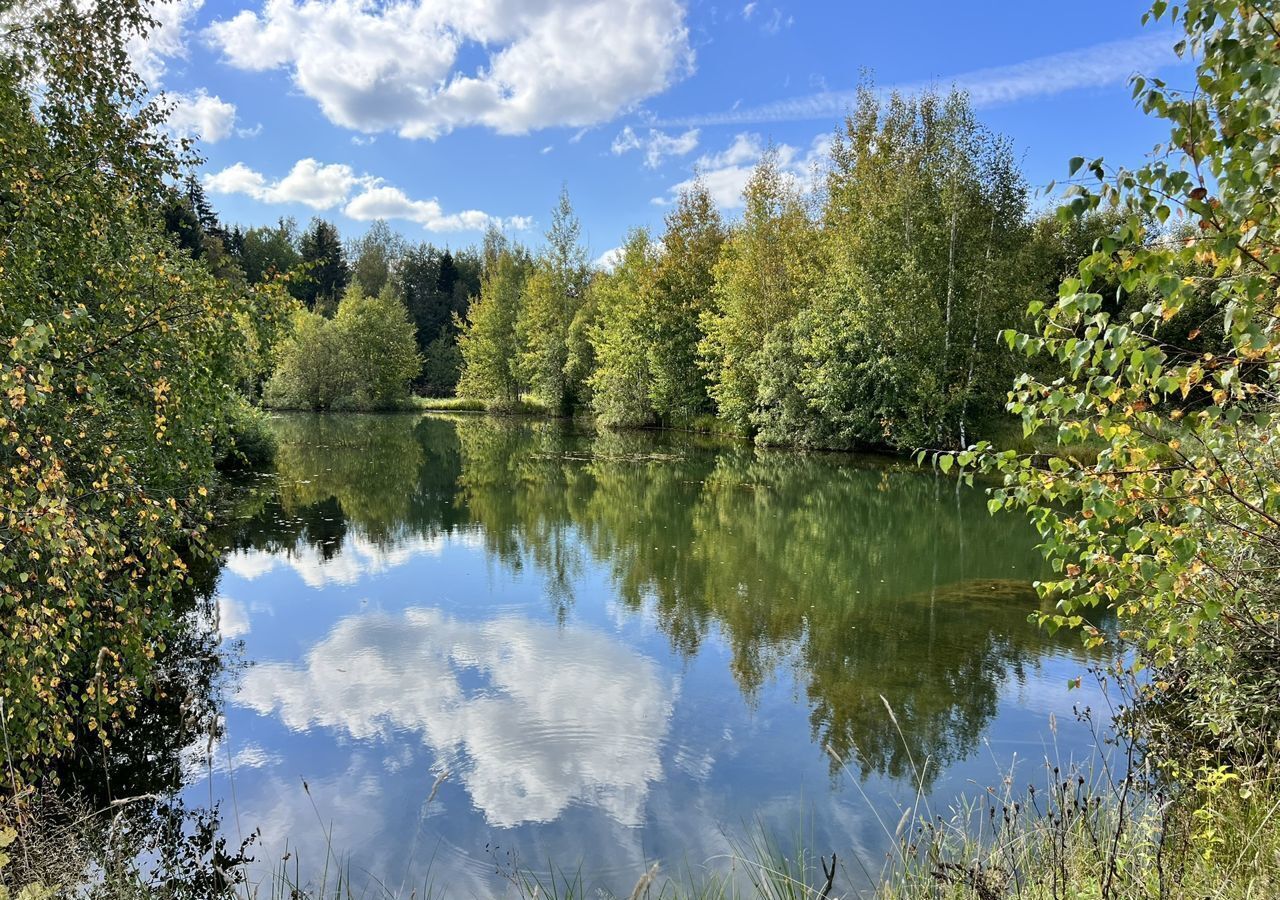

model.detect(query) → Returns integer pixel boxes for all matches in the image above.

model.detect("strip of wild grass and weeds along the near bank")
[0,703,1280,900]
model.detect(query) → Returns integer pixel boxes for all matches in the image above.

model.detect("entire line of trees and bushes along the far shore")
[212,88,1124,448]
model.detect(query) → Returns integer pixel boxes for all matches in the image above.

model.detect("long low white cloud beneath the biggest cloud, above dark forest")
[205,157,532,232]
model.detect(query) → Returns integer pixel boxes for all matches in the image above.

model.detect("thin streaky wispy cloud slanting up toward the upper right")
[658,33,1178,127]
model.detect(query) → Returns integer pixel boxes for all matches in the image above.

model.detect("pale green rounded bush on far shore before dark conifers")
[264,285,422,410]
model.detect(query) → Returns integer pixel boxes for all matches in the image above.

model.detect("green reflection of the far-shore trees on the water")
[217,415,1090,793]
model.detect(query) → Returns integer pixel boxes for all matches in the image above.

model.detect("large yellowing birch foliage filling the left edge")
[0,3,293,778]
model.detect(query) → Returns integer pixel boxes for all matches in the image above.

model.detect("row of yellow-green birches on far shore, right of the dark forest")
[458,90,1112,447]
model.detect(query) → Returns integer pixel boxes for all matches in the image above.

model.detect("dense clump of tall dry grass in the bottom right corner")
[874,769,1280,900]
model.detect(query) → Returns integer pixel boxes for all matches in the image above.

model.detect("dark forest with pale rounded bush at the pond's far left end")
[165,178,483,410]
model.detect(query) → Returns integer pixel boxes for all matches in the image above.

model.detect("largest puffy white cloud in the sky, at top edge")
[206,0,694,138]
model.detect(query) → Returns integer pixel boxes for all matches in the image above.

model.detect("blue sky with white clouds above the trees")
[145,0,1189,256]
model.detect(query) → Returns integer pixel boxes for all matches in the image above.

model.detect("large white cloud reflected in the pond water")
[236,609,675,827]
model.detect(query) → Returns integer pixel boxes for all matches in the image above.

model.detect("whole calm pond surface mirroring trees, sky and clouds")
[197,415,1111,896]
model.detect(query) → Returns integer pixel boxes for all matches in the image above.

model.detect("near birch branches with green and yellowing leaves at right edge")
[959,0,1280,763]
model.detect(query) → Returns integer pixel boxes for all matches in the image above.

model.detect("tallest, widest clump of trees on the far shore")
[754,88,1034,447]
